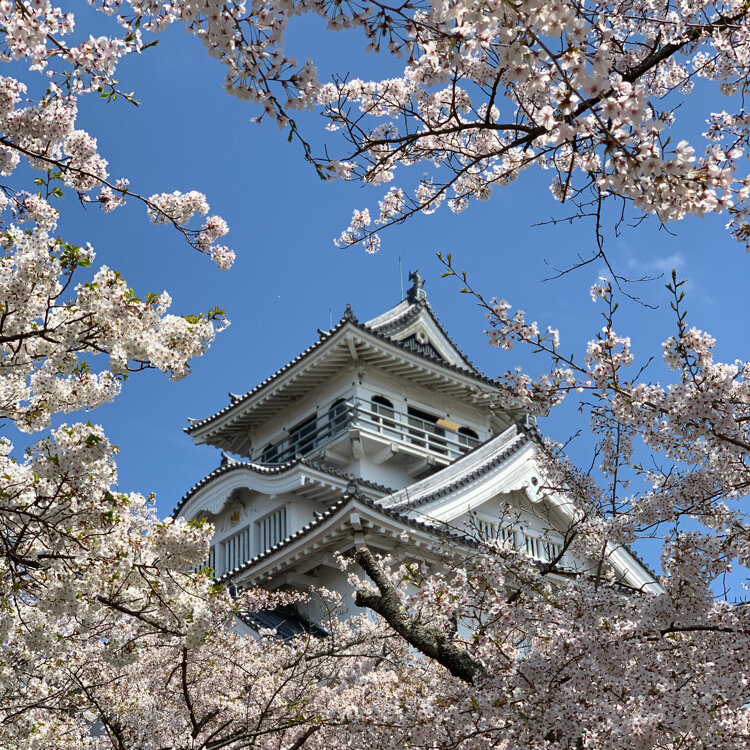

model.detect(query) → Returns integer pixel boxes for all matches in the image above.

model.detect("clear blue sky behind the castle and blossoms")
[6,9,750,568]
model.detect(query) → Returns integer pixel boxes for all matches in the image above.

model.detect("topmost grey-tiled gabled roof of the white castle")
[185,300,508,454]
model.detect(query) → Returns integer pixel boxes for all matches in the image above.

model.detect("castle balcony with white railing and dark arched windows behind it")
[253,399,480,476]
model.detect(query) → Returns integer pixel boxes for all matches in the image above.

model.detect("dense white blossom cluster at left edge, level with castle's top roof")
[0,226,221,431]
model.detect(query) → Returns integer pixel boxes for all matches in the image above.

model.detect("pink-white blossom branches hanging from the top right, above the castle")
[216,0,750,251]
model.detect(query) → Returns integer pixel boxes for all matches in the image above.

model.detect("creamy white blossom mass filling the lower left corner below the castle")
[0,424,397,750]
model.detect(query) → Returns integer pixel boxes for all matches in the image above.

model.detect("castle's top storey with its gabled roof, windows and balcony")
[186,273,512,489]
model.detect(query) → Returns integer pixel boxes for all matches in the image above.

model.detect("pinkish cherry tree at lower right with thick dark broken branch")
[328,266,750,750]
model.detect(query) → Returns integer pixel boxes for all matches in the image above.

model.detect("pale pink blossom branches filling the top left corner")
[0,0,234,268]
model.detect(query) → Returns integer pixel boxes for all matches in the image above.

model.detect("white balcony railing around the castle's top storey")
[255,400,479,463]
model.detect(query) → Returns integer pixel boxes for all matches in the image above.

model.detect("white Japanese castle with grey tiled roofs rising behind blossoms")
[174,273,658,637]
